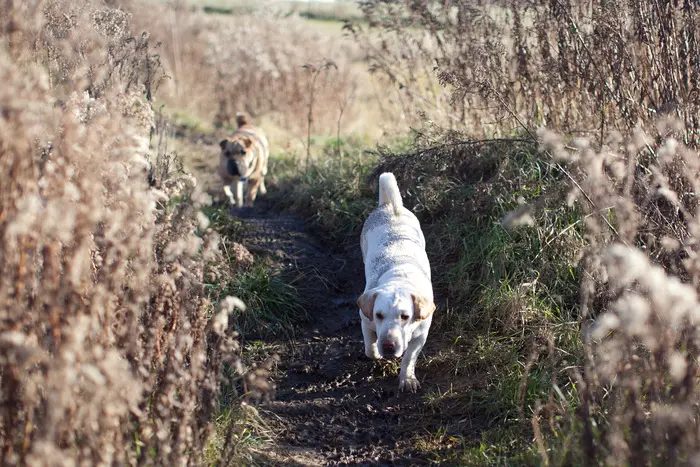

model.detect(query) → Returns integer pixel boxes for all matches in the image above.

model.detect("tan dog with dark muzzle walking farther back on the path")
[217,114,270,207]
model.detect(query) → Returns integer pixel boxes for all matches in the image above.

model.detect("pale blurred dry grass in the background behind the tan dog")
[123,2,388,139]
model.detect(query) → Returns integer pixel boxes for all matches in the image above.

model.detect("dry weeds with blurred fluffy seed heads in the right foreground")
[534,122,700,465]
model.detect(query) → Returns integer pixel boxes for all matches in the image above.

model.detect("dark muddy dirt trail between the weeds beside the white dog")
[234,200,442,466]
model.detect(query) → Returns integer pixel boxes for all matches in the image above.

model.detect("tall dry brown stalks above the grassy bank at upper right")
[355,0,698,144]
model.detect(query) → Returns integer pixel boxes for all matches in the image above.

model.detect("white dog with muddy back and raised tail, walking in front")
[357,173,435,391]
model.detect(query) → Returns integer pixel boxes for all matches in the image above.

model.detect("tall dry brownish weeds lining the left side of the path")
[0,0,274,465]
